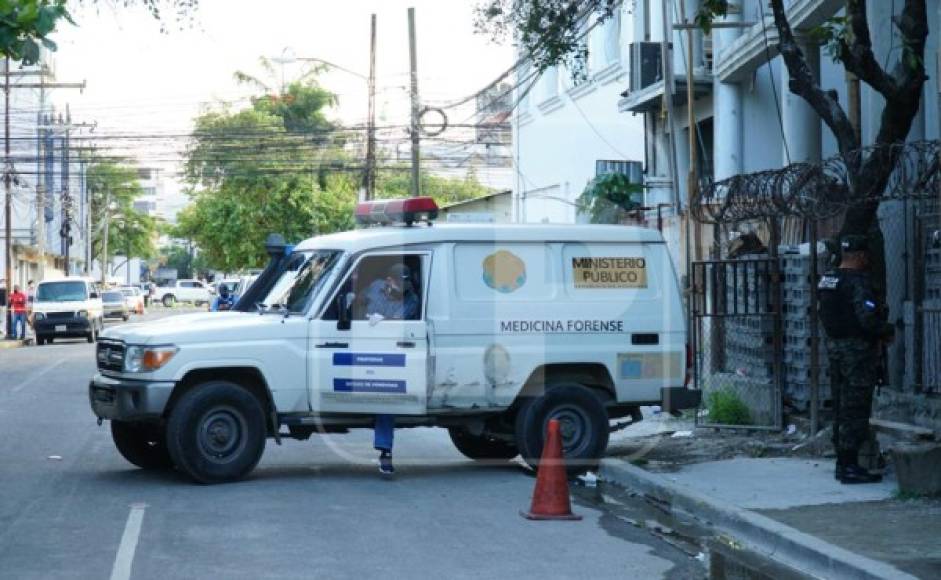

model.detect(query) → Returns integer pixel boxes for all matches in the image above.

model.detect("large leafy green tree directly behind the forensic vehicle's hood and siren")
[175,80,356,271]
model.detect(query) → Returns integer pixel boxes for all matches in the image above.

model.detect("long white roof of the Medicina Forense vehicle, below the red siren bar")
[296,224,663,252]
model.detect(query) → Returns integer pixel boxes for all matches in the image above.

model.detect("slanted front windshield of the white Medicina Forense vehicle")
[261,250,340,314]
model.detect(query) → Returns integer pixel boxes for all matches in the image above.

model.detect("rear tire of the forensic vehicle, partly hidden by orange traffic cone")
[516,383,609,476]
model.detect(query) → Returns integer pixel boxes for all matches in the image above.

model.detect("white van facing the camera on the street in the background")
[33,277,104,345]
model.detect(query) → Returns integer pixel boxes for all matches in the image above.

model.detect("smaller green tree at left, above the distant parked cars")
[87,160,159,276]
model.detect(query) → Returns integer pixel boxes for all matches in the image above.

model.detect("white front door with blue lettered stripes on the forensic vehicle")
[308,252,431,415]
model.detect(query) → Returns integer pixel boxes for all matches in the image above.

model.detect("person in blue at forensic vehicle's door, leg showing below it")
[365,263,418,475]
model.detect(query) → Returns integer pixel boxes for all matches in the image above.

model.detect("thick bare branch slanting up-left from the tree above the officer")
[771,0,859,154]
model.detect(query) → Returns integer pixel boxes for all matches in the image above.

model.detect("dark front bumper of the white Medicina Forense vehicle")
[88,373,176,421]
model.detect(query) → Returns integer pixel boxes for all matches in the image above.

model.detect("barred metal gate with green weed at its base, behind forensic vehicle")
[689,256,784,430]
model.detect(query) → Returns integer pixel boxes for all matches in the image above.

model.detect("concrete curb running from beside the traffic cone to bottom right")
[599,459,916,580]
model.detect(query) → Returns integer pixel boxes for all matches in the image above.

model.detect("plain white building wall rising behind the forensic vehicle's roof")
[513,2,644,223]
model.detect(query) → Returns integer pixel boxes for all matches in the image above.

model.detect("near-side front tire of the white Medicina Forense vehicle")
[167,381,267,484]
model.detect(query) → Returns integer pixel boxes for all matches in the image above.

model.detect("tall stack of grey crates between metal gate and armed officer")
[781,254,830,411]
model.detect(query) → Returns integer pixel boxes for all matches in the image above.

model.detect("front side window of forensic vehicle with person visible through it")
[323,254,424,320]
